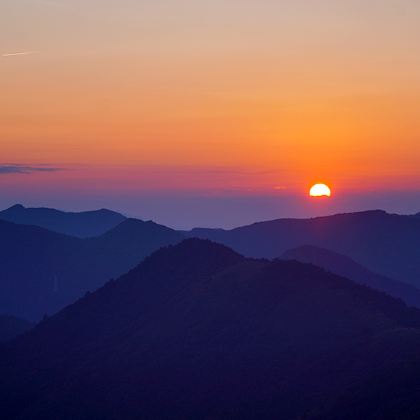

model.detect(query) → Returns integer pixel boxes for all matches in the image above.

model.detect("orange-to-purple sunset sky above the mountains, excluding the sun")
[0,0,420,227]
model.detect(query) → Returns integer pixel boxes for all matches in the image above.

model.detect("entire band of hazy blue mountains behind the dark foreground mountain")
[4,205,420,321]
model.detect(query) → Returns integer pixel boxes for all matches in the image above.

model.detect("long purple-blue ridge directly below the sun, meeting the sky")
[187,210,420,287]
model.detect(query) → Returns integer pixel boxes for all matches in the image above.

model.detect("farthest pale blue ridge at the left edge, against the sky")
[0,204,125,238]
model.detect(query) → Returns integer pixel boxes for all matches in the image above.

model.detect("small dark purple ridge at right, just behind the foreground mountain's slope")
[281,245,420,308]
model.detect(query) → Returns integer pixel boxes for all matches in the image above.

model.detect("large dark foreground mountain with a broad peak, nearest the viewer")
[0,239,420,420]
